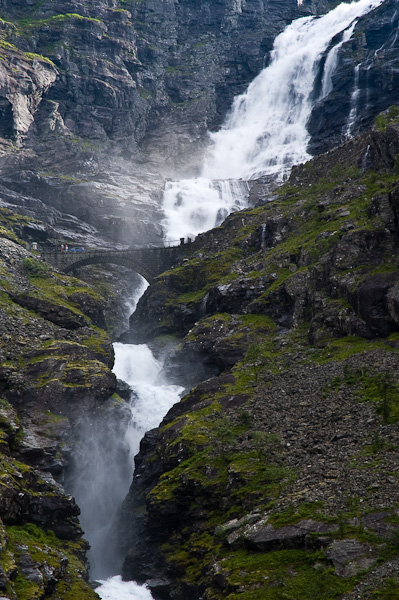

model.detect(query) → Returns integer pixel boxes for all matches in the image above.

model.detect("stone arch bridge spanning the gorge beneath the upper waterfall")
[41,240,194,283]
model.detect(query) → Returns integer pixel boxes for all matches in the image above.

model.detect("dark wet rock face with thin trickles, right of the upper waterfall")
[308,0,399,154]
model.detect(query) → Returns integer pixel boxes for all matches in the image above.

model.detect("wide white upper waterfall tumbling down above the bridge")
[163,0,383,241]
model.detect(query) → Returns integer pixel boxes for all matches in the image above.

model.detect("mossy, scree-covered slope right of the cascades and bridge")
[121,123,399,600]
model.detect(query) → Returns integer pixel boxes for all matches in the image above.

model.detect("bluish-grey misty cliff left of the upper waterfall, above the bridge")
[0,0,297,245]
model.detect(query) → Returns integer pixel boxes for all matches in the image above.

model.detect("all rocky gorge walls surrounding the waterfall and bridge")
[0,0,399,600]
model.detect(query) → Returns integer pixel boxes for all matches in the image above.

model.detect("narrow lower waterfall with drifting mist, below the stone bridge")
[66,280,184,600]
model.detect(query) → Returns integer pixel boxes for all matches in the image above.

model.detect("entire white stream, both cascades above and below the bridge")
[72,0,383,600]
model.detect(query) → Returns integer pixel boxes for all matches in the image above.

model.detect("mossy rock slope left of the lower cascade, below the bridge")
[0,208,124,600]
